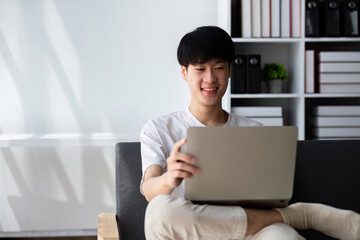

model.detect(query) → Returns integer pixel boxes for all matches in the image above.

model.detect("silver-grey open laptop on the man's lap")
[185,126,297,208]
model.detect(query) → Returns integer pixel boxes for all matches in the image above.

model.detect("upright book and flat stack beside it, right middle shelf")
[305,50,360,93]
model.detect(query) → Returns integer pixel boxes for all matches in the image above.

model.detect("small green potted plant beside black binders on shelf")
[263,63,288,93]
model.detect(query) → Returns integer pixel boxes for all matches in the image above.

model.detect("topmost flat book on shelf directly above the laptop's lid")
[231,106,282,117]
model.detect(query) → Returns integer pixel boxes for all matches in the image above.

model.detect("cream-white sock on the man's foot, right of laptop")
[275,203,360,240]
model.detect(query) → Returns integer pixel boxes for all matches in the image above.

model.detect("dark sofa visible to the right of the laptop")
[291,140,360,240]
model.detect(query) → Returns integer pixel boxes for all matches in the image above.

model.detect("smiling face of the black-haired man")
[181,59,230,106]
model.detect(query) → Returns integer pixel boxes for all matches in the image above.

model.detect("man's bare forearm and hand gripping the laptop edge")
[141,139,199,202]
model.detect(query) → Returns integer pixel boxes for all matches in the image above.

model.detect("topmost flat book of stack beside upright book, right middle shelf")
[317,51,360,62]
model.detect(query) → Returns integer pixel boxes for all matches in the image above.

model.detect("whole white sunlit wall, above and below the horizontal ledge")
[0,0,217,232]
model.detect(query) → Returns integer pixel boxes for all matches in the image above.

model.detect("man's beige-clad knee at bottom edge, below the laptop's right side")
[254,223,305,240]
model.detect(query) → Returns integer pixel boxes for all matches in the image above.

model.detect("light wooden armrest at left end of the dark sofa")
[97,213,119,240]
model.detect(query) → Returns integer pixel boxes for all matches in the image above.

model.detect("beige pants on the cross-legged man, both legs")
[145,195,304,240]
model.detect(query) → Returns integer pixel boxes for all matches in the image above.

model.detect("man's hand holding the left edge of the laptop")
[163,138,200,188]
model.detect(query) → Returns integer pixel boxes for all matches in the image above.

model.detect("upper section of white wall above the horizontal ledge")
[0,0,216,139]
